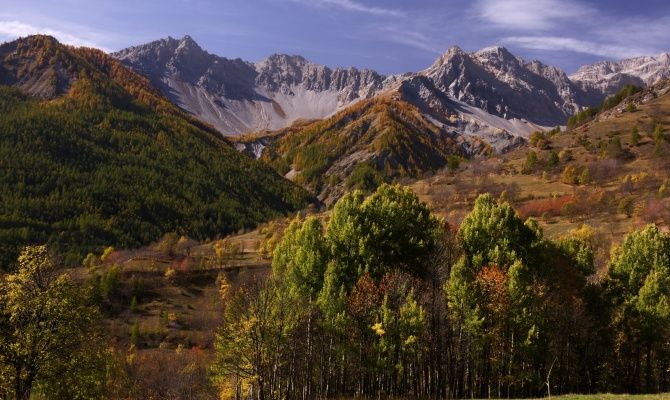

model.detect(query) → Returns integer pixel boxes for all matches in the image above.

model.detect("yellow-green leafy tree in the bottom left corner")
[0,246,105,400]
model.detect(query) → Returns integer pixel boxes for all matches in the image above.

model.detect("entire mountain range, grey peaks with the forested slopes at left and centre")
[0,36,670,253]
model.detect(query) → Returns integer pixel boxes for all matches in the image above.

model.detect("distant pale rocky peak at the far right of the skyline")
[570,53,670,96]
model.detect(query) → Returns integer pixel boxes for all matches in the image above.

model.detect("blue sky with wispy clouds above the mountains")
[0,0,670,74]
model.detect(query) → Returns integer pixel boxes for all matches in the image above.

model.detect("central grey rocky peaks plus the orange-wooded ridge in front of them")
[114,36,663,203]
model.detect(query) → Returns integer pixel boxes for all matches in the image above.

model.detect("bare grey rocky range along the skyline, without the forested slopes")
[112,36,670,151]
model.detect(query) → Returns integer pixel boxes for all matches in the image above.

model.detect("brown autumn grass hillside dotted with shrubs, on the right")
[412,82,670,247]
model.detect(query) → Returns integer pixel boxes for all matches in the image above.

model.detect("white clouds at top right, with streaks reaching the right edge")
[478,0,670,59]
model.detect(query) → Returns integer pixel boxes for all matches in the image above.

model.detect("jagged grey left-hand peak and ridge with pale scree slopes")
[113,36,384,135]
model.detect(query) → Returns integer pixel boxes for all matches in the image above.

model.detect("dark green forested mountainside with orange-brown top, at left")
[0,36,310,267]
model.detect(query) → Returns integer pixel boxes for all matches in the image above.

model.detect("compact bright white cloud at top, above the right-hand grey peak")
[475,0,593,31]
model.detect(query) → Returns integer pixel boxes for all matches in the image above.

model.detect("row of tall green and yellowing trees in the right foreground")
[213,184,670,400]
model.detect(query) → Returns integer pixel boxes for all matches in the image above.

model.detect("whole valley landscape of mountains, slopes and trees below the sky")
[0,21,670,400]
